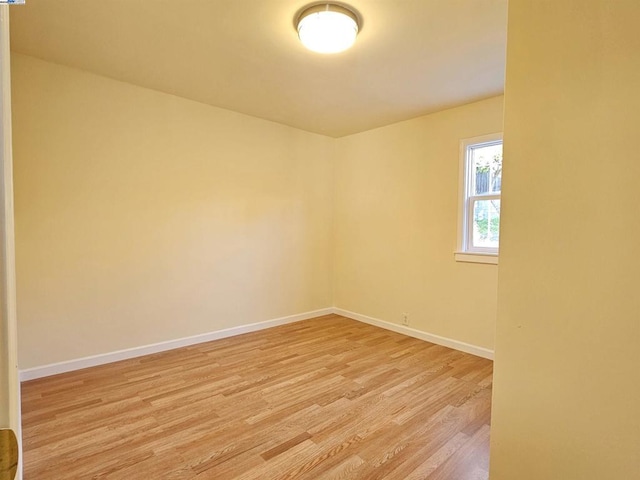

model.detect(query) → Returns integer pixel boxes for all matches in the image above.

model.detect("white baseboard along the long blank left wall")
[20,308,334,382]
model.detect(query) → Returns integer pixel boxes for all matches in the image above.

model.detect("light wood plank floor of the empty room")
[22,315,492,480]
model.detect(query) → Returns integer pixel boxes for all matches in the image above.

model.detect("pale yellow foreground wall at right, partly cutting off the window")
[491,0,640,480]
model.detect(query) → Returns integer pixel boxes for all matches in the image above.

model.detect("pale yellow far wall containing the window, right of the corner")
[334,97,502,349]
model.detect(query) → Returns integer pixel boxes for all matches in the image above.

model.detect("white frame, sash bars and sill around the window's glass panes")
[454,132,502,265]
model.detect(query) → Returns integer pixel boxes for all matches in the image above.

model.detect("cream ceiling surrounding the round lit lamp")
[10,0,507,137]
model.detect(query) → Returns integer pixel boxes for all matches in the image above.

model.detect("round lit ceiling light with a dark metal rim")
[296,3,359,53]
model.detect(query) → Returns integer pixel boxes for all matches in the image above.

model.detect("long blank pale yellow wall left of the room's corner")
[13,54,334,368]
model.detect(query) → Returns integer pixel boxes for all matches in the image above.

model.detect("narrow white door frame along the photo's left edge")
[0,4,22,480]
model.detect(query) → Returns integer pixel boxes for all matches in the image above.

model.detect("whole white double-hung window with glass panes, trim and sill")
[456,134,502,263]
